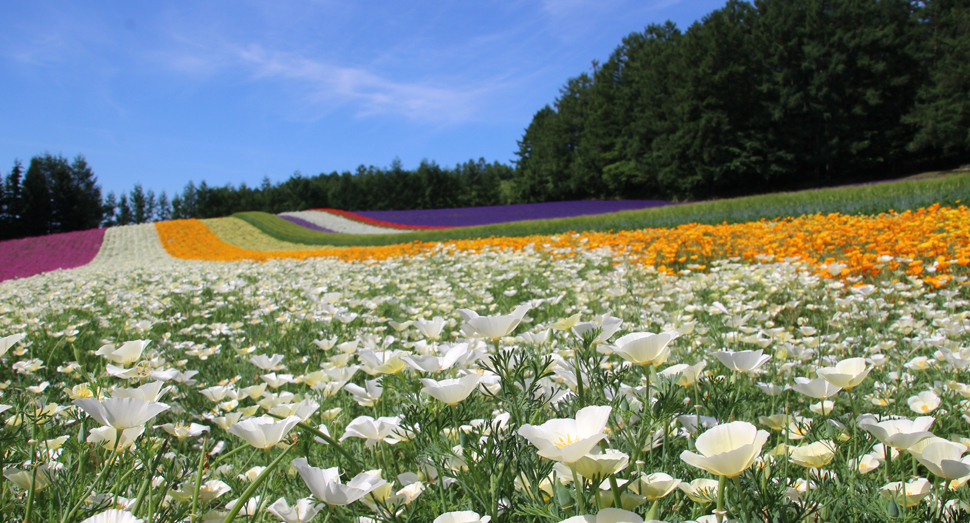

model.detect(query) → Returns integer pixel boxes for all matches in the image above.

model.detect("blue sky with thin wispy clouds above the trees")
[0,0,724,201]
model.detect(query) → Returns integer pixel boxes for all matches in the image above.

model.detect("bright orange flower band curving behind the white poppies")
[156,205,970,285]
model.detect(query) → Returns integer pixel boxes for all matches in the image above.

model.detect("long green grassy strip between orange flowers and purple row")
[233,171,970,246]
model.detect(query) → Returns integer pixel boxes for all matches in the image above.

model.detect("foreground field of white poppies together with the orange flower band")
[0,205,970,523]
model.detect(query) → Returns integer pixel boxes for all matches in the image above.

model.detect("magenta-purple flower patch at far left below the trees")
[0,229,104,281]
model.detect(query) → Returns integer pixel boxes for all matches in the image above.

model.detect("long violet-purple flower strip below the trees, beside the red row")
[357,200,671,227]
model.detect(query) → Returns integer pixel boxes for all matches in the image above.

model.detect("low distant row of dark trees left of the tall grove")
[0,157,515,240]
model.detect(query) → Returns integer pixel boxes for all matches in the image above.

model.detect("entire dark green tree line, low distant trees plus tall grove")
[0,0,970,239]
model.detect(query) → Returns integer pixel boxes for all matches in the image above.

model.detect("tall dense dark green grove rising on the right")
[515,0,970,202]
